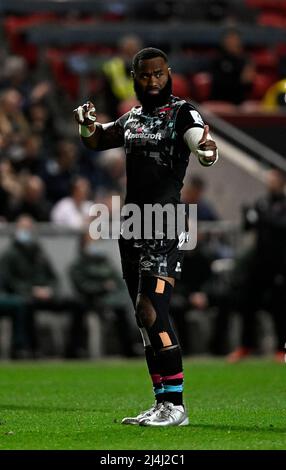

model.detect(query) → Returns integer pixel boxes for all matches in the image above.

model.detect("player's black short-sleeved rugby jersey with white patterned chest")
[101,96,204,206]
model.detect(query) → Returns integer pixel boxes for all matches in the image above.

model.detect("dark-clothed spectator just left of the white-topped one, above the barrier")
[9,175,51,222]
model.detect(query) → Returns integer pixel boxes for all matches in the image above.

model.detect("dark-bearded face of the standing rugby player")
[134,57,170,96]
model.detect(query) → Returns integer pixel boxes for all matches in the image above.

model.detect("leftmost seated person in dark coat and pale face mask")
[0,215,85,354]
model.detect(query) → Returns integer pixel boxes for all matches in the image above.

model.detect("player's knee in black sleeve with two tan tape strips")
[136,276,178,351]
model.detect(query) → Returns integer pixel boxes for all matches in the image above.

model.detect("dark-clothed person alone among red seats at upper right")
[210,29,255,105]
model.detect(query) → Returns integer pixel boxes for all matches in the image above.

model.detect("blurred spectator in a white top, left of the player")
[51,177,93,229]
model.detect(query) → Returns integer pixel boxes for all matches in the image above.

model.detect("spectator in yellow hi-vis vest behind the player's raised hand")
[103,35,142,119]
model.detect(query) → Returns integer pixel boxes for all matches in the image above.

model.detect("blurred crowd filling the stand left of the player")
[0,56,127,228]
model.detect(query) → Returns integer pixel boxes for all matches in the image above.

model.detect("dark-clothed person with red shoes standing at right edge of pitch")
[229,170,286,362]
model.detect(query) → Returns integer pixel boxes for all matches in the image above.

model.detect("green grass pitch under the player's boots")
[0,360,286,450]
